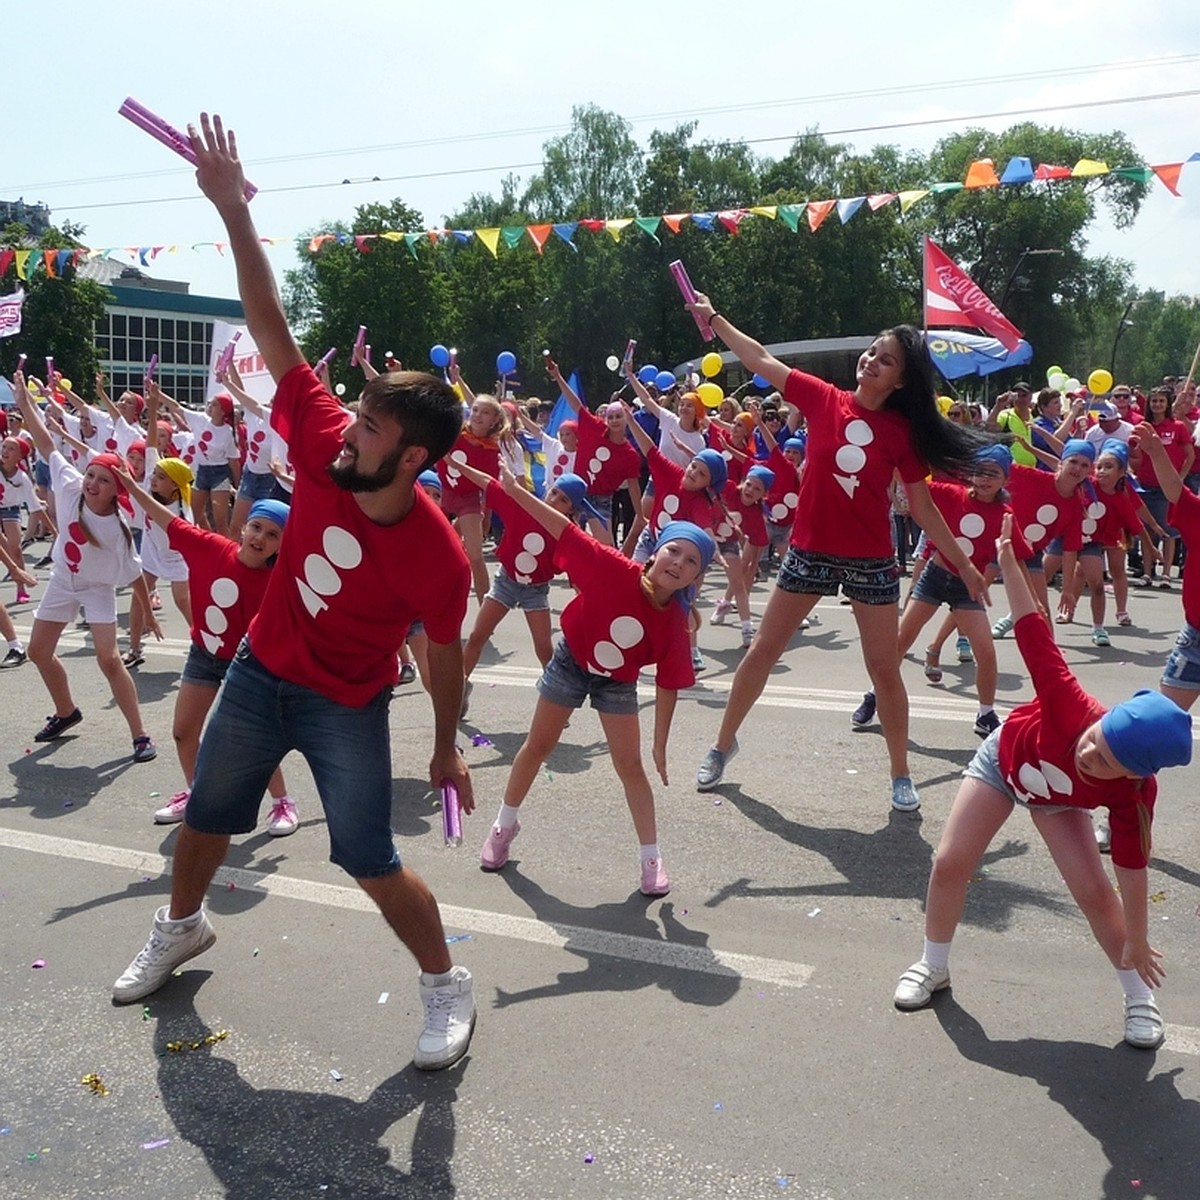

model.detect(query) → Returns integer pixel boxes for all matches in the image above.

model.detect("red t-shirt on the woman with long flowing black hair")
[784,371,929,558]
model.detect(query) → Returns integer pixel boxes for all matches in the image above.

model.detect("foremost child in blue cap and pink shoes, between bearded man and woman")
[479,467,716,896]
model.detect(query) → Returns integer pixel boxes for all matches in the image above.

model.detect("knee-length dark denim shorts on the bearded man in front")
[186,640,400,880]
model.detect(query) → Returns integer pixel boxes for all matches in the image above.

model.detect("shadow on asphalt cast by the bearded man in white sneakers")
[154,970,469,1200]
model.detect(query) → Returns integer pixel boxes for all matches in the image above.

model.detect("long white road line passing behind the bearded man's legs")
[0,828,815,988]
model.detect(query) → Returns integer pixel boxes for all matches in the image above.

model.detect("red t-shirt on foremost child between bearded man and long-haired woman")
[554,526,696,691]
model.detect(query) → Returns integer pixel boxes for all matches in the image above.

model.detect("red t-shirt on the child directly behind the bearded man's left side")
[167,517,271,660]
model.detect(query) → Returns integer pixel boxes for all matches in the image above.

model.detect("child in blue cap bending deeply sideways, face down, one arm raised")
[894,517,1192,1049]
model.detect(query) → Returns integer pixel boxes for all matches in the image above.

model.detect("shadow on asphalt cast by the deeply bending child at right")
[932,993,1200,1200]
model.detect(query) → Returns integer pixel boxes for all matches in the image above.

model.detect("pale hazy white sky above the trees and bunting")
[0,0,1200,309]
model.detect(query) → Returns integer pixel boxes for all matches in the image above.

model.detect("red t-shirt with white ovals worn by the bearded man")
[250,364,470,708]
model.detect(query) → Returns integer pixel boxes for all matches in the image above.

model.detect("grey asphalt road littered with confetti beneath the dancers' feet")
[0,564,1200,1200]
